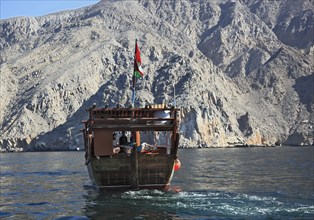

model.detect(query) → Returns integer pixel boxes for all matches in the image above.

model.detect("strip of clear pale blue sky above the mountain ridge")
[0,0,100,19]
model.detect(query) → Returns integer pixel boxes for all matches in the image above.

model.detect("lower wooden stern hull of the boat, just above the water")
[87,153,174,189]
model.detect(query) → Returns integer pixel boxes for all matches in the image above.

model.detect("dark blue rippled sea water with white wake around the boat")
[0,147,314,219]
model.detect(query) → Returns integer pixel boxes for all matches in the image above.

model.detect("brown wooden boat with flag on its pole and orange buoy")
[83,42,181,189]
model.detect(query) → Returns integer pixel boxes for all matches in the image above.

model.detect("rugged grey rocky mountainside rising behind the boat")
[0,0,314,151]
